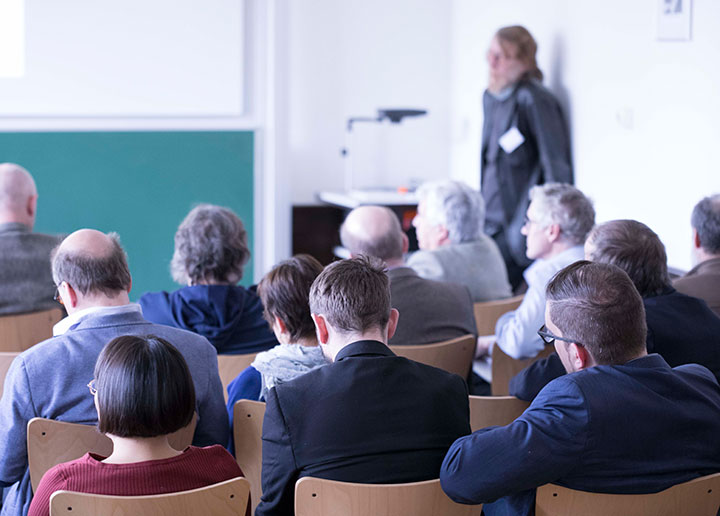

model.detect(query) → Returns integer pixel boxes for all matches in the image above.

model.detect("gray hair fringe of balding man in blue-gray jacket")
[50,233,131,297]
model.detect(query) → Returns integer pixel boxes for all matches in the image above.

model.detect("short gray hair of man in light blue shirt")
[530,183,595,245]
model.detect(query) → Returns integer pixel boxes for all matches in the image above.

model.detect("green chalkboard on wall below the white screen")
[0,131,253,300]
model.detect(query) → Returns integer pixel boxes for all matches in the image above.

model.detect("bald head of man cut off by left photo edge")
[0,163,37,229]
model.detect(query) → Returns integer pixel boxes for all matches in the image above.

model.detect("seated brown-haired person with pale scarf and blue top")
[227,254,327,408]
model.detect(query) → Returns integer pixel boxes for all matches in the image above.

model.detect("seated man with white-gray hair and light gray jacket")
[407,181,512,303]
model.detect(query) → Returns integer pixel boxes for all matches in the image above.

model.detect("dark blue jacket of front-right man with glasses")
[440,354,720,516]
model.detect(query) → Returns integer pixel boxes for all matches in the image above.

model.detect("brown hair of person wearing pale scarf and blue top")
[258,254,323,341]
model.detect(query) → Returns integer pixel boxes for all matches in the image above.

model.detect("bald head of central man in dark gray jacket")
[340,206,407,264]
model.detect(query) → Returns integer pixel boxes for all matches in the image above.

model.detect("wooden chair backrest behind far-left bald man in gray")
[0,308,63,351]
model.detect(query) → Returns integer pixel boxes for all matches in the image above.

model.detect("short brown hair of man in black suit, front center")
[310,256,390,333]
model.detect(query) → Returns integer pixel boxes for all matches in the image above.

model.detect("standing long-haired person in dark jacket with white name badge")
[481,25,573,288]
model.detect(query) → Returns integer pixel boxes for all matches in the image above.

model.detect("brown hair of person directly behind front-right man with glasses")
[586,219,670,297]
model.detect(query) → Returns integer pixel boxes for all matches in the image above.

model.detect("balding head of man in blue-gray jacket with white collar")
[52,229,131,302]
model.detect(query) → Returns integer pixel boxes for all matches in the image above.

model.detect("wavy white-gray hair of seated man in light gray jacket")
[417,181,485,244]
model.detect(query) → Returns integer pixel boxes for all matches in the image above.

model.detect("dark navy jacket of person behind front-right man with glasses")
[510,287,720,401]
